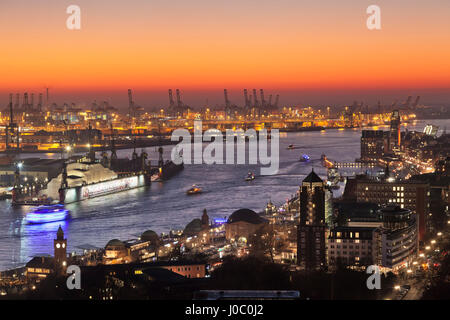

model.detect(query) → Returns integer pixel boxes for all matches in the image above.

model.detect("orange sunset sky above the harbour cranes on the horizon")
[0,0,450,106]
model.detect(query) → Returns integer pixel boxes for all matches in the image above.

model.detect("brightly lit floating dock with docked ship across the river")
[31,129,183,204]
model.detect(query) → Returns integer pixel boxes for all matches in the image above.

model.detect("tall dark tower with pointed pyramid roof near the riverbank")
[297,170,328,271]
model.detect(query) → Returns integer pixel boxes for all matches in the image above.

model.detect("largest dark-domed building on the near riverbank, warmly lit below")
[225,209,267,241]
